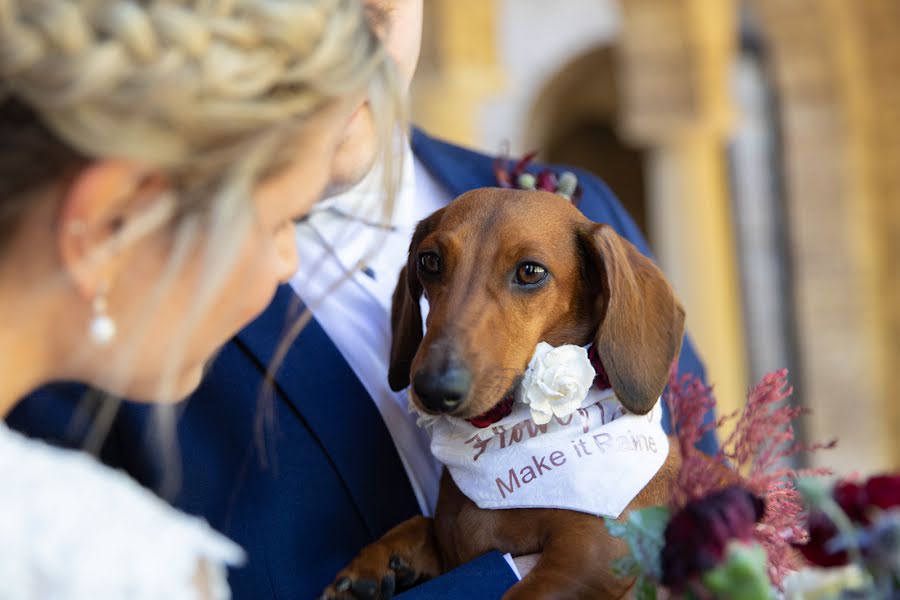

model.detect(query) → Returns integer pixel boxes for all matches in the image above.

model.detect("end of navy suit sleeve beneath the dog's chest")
[395,552,519,600]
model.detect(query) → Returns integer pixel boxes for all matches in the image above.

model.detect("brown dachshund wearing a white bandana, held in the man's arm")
[323,189,684,599]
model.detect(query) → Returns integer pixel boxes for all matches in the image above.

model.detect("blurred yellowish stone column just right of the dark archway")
[619,0,747,424]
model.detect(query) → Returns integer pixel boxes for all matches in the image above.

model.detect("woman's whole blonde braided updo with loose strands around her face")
[0,0,405,478]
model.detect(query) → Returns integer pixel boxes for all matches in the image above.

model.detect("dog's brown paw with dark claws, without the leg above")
[319,547,423,600]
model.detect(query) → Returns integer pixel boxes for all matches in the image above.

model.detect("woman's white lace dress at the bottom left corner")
[0,421,243,600]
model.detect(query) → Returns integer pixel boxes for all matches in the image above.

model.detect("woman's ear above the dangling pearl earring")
[56,160,174,298]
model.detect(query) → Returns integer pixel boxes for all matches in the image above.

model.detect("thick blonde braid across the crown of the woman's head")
[0,0,383,162]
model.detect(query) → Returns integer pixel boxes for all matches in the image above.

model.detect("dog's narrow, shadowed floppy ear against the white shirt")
[388,210,443,392]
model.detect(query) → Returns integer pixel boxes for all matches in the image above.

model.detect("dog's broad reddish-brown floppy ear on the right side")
[581,224,684,414]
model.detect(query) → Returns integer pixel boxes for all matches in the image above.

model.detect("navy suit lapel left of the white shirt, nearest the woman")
[238,285,419,538]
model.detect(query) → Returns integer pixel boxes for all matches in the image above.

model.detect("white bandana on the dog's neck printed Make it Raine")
[410,388,669,518]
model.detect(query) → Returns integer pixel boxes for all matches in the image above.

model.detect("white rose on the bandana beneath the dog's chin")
[522,342,596,425]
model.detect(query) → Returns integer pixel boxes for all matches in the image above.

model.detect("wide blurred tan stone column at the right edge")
[753,0,900,473]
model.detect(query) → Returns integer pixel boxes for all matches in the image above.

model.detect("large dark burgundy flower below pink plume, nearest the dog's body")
[661,485,765,593]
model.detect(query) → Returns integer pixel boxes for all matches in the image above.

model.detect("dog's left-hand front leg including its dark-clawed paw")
[321,516,441,600]
